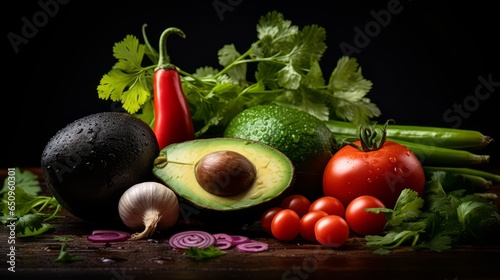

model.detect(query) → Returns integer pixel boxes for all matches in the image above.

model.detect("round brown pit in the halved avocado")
[195,150,257,196]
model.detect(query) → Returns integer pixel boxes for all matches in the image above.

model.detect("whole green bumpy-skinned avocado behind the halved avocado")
[224,104,338,199]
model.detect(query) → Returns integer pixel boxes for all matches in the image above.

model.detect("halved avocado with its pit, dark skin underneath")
[153,138,295,222]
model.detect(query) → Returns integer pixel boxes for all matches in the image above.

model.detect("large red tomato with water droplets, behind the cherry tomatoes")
[323,140,425,208]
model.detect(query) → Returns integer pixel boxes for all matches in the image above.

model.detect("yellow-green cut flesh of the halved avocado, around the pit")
[153,138,294,211]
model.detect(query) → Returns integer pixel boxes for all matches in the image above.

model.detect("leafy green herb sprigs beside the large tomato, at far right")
[365,173,500,254]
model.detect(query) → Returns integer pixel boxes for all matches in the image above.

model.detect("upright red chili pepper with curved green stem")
[153,27,195,149]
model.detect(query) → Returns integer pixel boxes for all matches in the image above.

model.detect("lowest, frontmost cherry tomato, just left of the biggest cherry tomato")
[314,215,349,247]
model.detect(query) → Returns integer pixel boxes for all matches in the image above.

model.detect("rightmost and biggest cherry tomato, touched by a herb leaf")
[345,195,387,235]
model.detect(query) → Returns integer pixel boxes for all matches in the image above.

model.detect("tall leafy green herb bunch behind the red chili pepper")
[97,11,380,136]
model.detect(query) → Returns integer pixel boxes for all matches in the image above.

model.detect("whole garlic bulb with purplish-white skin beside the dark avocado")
[118,182,179,240]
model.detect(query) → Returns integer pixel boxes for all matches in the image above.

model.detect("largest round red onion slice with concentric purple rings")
[168,230,216,249]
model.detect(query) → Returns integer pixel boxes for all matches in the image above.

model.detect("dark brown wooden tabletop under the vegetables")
[0,168,500,280]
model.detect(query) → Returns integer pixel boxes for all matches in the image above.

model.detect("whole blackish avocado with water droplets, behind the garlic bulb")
[41,112,159,224]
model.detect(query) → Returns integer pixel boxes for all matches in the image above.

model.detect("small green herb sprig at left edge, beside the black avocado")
[0,168,62,237]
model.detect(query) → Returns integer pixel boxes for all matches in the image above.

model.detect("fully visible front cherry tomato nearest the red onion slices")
[271,209,300,241]
